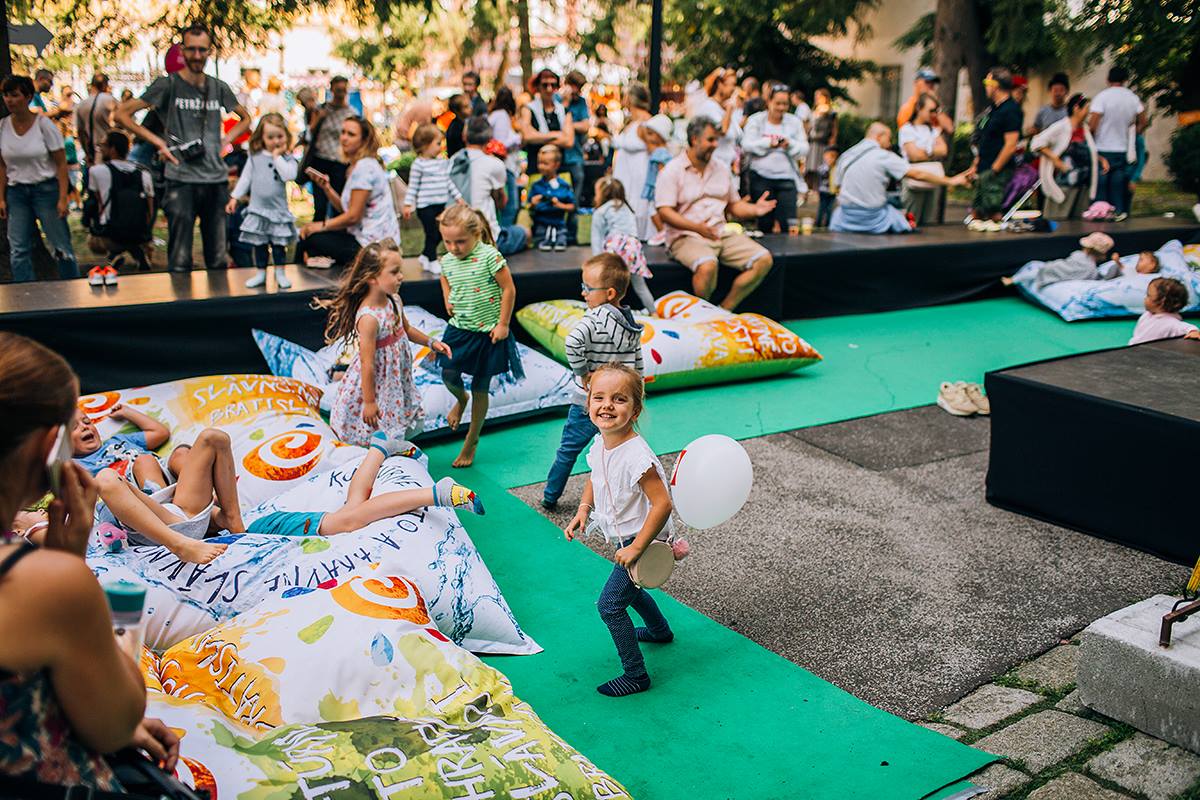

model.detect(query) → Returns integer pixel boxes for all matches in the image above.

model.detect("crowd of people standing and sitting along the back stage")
[0,25,1176,308]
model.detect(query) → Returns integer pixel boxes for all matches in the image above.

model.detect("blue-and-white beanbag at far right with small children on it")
[1013,240,1200,323]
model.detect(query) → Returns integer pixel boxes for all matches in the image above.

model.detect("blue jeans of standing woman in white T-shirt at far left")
[7,178,79,282]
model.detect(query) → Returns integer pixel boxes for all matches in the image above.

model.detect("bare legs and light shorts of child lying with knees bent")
[96,428,246,564]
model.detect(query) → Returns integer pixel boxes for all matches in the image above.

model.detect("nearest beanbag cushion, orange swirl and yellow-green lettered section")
[143,569,629,800]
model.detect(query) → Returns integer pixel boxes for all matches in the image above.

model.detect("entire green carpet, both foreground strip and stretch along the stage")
[427,299,1133,800]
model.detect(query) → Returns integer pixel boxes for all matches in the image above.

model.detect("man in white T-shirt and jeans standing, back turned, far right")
[1087,67,1147,219]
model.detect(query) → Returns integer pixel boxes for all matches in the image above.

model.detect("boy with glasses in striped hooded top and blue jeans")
[541,253,642,511]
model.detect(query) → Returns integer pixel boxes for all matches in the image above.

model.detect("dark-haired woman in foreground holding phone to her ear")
[0,333,179,790]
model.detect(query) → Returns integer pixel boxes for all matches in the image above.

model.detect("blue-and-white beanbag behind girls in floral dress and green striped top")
[253,306,571,433]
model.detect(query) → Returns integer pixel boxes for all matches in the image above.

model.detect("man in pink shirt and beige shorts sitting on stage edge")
[654,116,775,311]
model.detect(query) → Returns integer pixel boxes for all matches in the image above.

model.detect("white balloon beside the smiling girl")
[671,433,754,528]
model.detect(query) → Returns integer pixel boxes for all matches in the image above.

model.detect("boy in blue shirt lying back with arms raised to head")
[71,403,170,492]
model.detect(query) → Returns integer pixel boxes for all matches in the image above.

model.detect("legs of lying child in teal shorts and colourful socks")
[246,431,484,536]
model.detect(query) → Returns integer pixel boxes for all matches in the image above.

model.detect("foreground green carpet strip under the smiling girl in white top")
[460,479,992,800]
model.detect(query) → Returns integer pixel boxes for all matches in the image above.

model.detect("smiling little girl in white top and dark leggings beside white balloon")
[563,363,674,697]
